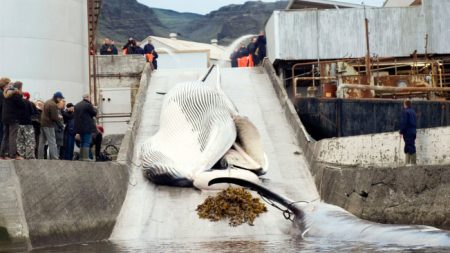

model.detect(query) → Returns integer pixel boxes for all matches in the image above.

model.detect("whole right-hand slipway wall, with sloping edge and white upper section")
[263,60,450,229]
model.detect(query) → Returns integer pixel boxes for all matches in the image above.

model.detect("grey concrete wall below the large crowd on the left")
[0,160,128,247]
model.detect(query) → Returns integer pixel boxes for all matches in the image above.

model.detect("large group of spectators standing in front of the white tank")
[0,78,104,161]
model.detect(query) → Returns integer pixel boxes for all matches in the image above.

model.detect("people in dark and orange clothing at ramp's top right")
[230,31,267,68]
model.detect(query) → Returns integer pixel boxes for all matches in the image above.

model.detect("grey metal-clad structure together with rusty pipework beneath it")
[266,0,450,100]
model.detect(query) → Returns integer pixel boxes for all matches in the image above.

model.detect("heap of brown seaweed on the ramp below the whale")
[196,187,267,227]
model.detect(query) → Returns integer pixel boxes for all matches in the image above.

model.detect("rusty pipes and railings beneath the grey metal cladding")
[291,56,450,100]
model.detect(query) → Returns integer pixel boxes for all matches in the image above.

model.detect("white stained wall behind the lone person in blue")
[314,127,450,167]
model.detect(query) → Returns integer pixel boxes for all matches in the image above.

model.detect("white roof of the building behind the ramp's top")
[142,36,228,60]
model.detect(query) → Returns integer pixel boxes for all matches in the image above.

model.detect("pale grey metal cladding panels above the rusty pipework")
[266,0,450,62]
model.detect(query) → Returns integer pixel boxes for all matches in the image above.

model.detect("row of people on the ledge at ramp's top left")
[100,38,158,69]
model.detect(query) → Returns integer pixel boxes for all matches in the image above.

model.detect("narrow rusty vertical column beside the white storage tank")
[87,0,102,105]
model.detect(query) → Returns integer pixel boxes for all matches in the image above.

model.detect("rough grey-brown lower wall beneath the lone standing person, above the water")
[312,163,450,230]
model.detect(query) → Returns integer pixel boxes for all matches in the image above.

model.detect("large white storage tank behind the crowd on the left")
[0,0,89,102]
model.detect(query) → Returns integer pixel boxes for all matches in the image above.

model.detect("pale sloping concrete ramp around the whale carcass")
[111,68,319,241]
